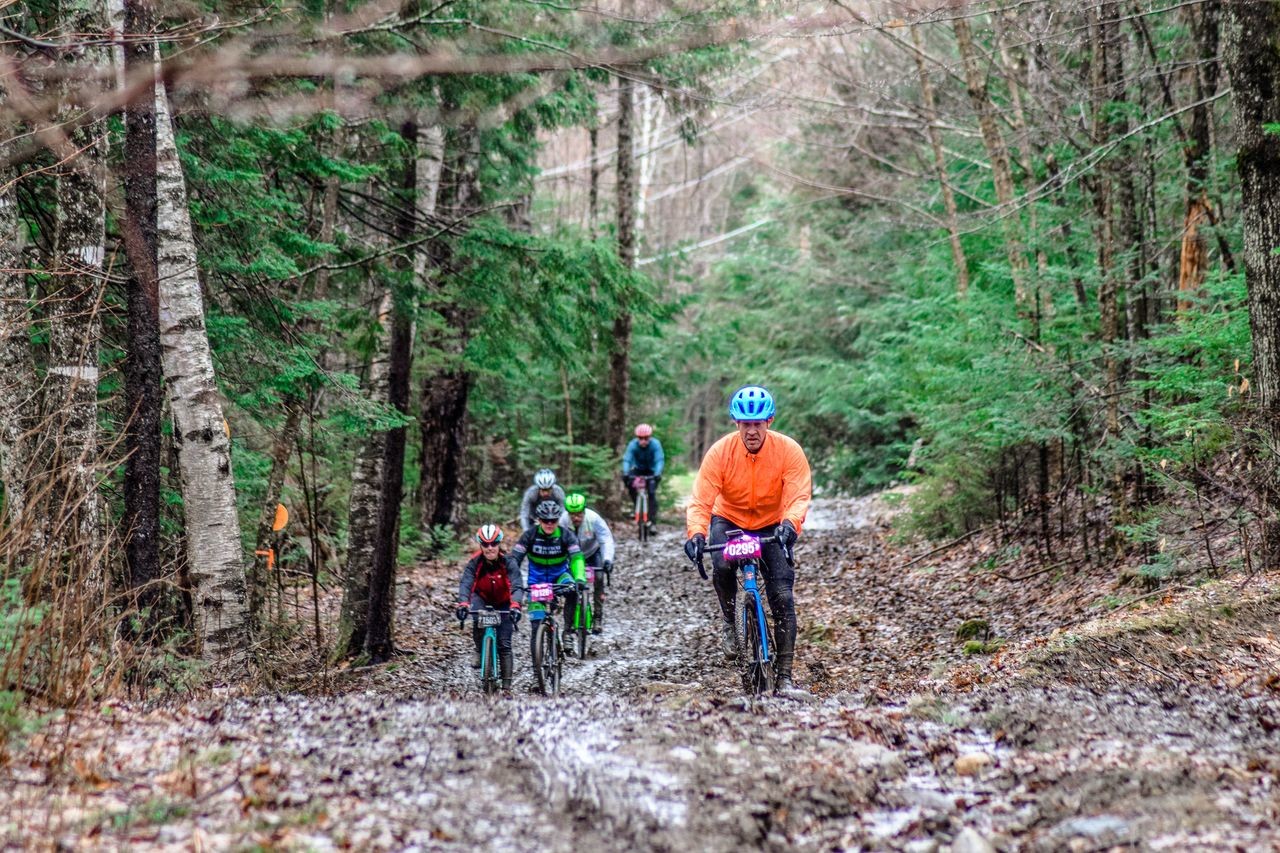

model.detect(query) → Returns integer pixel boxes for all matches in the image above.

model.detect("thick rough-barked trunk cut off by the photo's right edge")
[1225,0,1280,570]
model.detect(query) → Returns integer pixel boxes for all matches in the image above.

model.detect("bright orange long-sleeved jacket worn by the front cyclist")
[685,430,812,538]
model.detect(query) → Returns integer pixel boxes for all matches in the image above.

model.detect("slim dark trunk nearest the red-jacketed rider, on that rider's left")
[365,122,417,663]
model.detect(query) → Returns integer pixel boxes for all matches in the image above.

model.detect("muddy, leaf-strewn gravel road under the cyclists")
[0,499,1280,853]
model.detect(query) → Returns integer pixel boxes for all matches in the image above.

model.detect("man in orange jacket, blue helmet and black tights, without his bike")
[685,386,812,693]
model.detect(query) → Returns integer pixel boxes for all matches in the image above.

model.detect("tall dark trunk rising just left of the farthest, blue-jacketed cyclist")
[605,64,636,516]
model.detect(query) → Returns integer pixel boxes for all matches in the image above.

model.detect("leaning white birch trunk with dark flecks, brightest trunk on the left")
[156,83,247,662]
